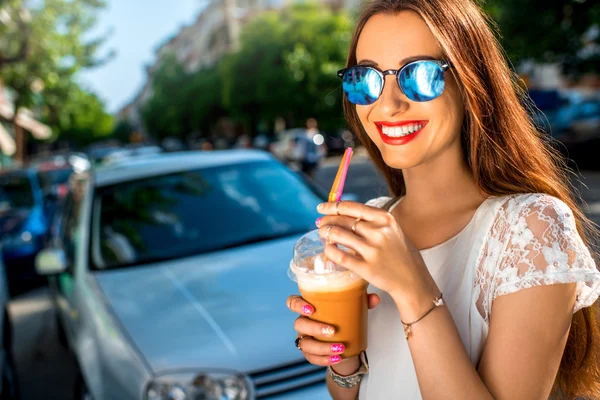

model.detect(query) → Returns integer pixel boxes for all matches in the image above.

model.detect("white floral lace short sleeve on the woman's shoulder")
[486,194,600,319]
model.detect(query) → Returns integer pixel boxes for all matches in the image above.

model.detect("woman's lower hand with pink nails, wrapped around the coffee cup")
[287,294,380,370]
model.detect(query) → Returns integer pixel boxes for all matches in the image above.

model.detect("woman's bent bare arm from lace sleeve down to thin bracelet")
[399,284,576,400]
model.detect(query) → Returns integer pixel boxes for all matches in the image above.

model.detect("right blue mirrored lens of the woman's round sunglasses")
[398,61,445,102]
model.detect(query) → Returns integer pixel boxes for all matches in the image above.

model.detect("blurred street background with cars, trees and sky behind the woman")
[0,0,600,400]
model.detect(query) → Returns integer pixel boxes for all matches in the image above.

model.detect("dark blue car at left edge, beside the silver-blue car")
[0,169,48,293]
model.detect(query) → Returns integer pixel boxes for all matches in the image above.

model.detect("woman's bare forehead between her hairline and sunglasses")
[356,10,442,69]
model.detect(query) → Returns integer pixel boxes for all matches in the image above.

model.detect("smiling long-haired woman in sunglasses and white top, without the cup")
[288,0,600,400]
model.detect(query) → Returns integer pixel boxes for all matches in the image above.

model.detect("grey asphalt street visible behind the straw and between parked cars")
[10,154,600,400]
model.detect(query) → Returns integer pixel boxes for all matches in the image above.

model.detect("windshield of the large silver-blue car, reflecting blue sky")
[90,161,324,269]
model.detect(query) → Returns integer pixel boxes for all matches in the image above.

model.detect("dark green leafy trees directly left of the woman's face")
[143,4,351,138]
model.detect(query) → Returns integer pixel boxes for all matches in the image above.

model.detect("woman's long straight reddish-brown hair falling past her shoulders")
[343,0,600,399]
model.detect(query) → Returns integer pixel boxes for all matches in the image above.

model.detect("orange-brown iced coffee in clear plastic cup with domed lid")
[289,230,368,358]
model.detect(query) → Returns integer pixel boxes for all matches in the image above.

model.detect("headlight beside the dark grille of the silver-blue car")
[146,373,252,400]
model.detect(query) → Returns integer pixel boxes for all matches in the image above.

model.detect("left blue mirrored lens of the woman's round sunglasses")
[342,67,383,106]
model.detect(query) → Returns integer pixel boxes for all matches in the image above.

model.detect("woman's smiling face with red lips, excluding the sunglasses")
[356,11,464,169]
